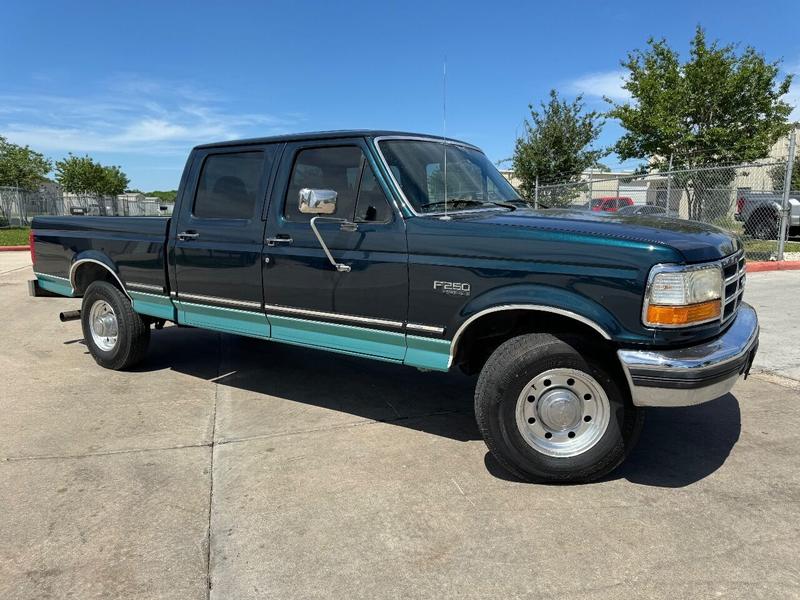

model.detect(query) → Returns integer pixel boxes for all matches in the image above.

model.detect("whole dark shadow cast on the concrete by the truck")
[137,327,741,487]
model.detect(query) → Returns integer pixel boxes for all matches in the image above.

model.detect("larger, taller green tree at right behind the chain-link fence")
[606,27,792,219]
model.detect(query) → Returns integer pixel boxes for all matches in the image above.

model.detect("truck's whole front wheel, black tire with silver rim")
[475,333,644,483]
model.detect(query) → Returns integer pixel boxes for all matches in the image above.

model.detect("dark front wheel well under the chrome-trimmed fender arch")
[453,309,619,374]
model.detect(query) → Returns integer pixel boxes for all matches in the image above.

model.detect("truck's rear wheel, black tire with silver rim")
[81,281,150,371]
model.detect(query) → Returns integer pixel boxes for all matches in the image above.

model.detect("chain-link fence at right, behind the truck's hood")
[534,134,800,260]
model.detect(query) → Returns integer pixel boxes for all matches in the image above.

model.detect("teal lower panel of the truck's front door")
[269,315,406,362]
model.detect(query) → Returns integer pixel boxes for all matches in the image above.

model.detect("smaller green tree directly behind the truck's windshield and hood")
[512,90,608,205]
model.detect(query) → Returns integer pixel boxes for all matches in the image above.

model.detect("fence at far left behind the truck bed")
[0,187,173,227]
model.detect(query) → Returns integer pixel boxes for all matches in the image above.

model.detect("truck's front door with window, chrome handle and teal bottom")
[262,138,408,361]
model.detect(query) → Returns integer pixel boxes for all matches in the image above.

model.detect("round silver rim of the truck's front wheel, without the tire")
[516,369,611,458]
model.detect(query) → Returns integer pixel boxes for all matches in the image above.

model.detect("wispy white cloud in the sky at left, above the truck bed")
[0,76,302,155]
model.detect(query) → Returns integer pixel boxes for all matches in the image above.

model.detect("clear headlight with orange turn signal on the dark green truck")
[642,264,722,327]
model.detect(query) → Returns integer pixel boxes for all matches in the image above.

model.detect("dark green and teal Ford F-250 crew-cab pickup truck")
[30,131,759,482]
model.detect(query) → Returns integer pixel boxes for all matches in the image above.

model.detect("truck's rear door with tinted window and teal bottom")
[171,145,278,337]
